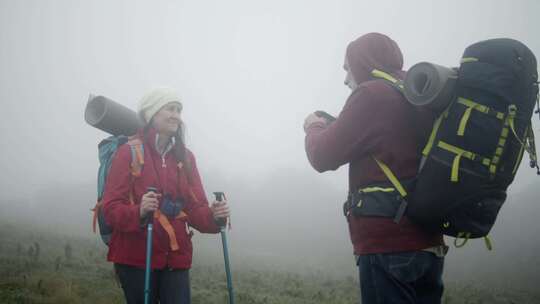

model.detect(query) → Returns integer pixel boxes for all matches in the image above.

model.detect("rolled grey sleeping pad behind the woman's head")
[84,95,143,136]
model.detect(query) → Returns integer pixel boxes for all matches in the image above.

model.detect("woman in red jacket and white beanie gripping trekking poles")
[103,88,229,304]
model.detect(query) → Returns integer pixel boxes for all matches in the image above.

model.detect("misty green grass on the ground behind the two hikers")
[0,224,540,304]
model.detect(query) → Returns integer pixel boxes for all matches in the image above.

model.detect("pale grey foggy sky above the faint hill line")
[0,0,540,198]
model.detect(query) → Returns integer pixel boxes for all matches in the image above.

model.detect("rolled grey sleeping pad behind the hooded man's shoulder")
[403,62,457,112]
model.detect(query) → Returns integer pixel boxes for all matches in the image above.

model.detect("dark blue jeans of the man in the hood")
[358,251,444,304]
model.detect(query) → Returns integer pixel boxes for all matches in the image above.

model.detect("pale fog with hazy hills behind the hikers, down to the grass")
[0,0,540,290]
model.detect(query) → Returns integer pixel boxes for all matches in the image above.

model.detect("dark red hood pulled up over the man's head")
[345,33,403,84]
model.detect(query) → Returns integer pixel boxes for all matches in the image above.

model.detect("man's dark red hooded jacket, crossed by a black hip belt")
[305,34,442,255]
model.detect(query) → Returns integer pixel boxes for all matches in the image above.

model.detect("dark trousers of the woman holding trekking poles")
[114,264,191,304]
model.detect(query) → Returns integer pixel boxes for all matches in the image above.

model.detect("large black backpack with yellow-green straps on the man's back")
[364,39,540,248]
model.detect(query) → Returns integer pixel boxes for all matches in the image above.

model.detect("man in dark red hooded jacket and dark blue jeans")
[304,33,446,304]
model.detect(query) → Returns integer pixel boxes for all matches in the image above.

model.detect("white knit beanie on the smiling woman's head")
[138,87,182,123]
